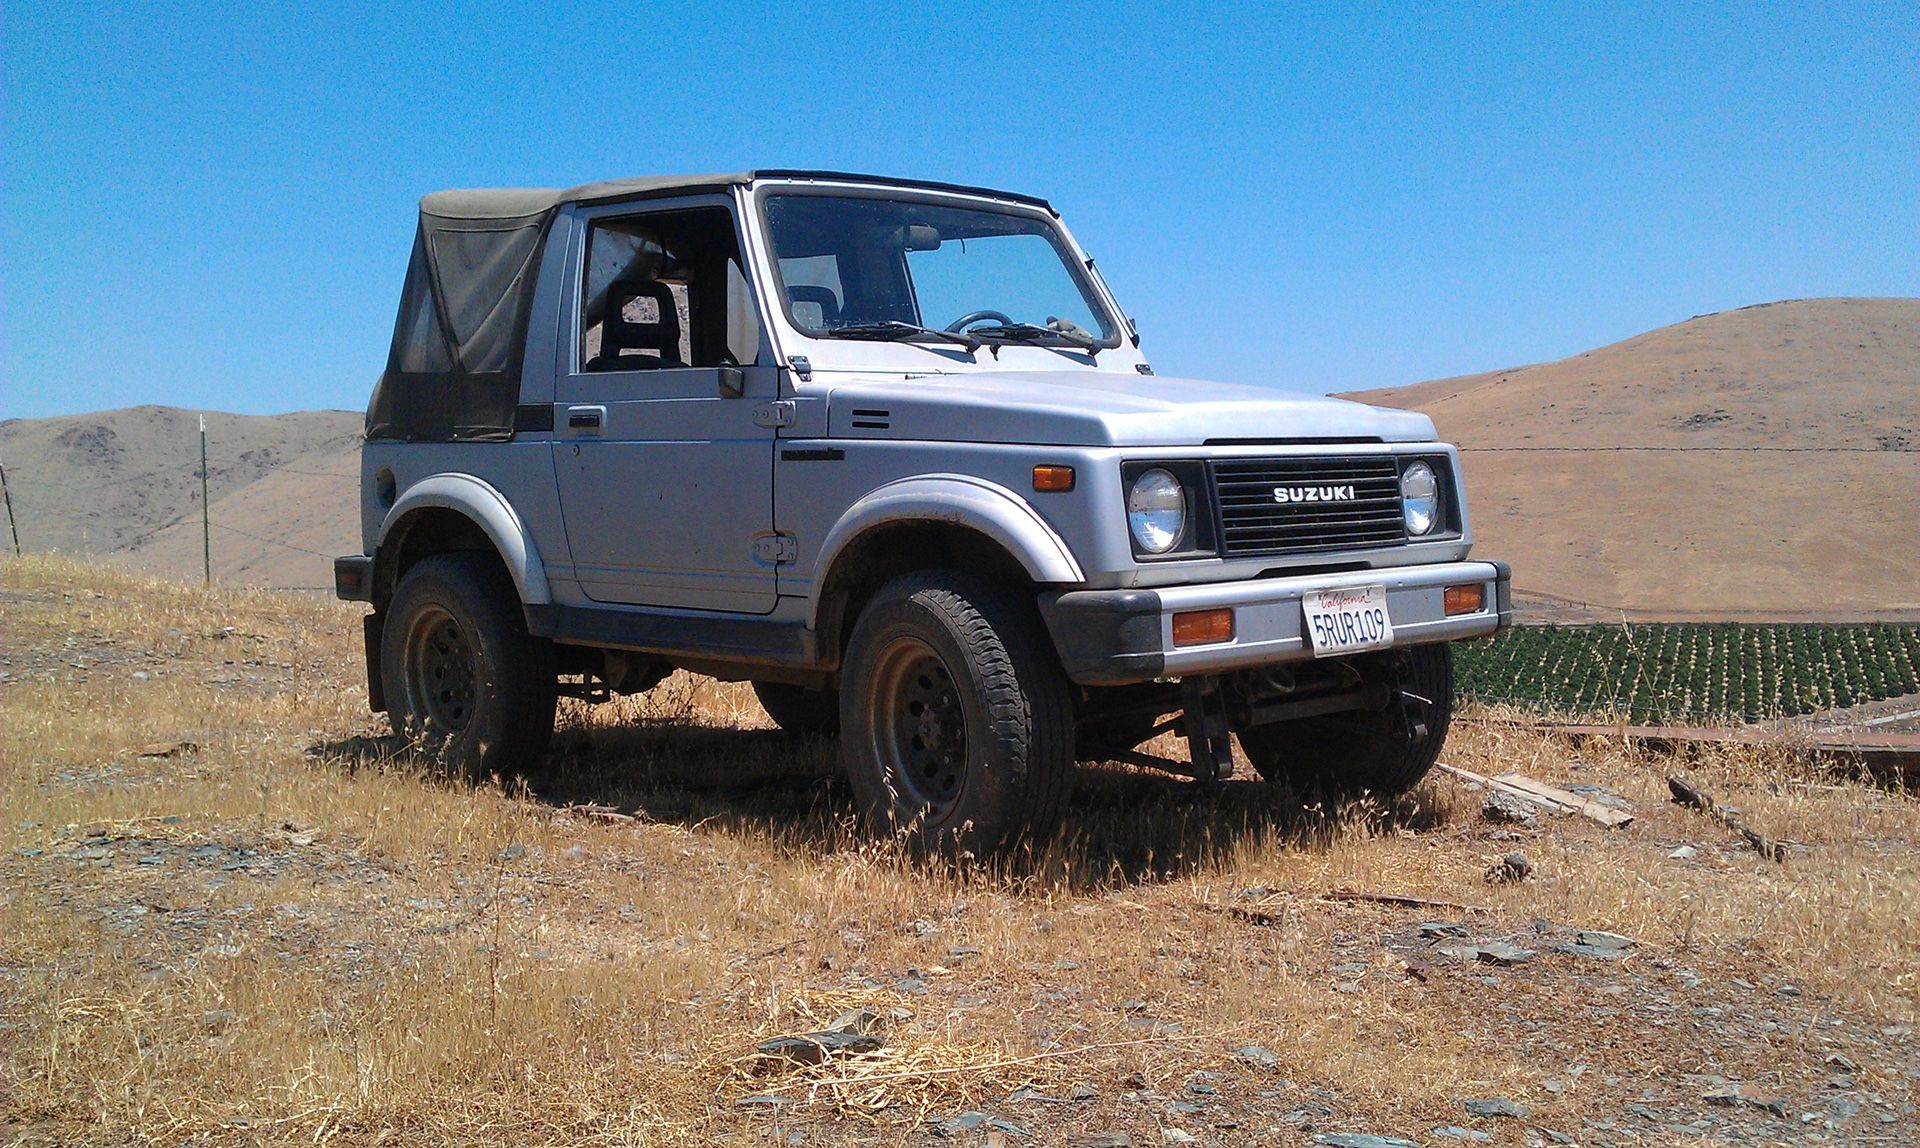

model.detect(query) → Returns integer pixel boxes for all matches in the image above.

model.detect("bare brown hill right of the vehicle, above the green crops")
[1350,299,1920,620]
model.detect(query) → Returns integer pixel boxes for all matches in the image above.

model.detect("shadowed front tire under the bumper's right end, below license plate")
[1240,643,1453,801]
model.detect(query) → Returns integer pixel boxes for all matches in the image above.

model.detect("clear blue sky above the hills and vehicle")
[0,0,1920,417]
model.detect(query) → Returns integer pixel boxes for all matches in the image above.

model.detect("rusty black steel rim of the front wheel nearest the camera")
[868,635,968,822]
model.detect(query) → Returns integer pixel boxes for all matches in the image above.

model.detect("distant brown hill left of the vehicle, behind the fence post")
[0,407,361,586]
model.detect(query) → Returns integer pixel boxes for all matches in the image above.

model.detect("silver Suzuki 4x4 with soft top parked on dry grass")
[345,171,1511,852]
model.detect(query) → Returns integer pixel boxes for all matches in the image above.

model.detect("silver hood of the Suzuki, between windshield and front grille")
[828,371,1434,447]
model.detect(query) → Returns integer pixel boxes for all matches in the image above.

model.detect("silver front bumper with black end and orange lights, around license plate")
[1041,562,1513,685]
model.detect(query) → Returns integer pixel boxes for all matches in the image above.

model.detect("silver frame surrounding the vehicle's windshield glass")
[749,180,1131,355]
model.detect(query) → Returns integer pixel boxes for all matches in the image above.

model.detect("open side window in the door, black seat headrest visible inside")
[580,207,760,371]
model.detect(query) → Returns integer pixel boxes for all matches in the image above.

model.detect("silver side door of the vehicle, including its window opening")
[553,196,778,614]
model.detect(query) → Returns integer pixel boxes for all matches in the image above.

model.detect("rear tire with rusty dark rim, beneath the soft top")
[380,553,555,779]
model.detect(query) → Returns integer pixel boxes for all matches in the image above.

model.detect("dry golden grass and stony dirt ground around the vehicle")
[0,559,1920,1148]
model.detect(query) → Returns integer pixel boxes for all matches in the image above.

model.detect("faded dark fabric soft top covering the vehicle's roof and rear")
[367,171,1046,442]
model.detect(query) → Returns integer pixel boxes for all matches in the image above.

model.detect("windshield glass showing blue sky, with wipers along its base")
[766,194,1119,347]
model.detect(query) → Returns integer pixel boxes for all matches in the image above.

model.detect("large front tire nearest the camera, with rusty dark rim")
[841,570,1073,856]
